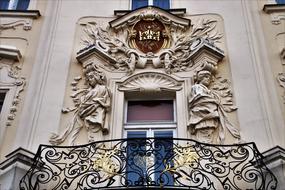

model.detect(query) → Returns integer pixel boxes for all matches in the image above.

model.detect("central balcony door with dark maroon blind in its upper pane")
[125,100,176,185]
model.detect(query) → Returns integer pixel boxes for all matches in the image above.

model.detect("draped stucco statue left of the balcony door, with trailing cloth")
[49,63,111,145]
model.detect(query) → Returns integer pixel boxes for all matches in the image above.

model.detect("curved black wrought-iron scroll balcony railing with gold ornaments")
[20,138,277,190]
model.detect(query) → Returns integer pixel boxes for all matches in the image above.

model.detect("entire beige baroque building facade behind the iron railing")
[0,0,285,190]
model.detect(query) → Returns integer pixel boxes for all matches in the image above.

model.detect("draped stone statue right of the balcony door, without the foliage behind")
[188,70,240,144]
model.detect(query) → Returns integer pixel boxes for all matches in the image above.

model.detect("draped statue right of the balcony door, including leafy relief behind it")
[188,69,240,144]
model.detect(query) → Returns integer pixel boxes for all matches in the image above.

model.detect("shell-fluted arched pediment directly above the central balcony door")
[119,72,182,92]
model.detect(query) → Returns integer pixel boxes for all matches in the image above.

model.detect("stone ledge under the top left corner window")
[0,9,41,19]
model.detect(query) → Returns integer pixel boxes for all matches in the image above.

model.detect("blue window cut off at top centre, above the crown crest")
[132,0,170,10]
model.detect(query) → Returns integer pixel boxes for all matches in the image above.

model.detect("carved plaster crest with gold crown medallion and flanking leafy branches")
[78,12,223,74]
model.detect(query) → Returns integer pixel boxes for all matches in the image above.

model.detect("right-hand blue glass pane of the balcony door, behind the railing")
[154,131,174,185]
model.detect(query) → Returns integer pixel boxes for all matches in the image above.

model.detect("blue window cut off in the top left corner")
[0,0,30,10]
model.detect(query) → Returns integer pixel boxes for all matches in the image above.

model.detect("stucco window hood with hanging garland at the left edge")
[0,46,26,126]
